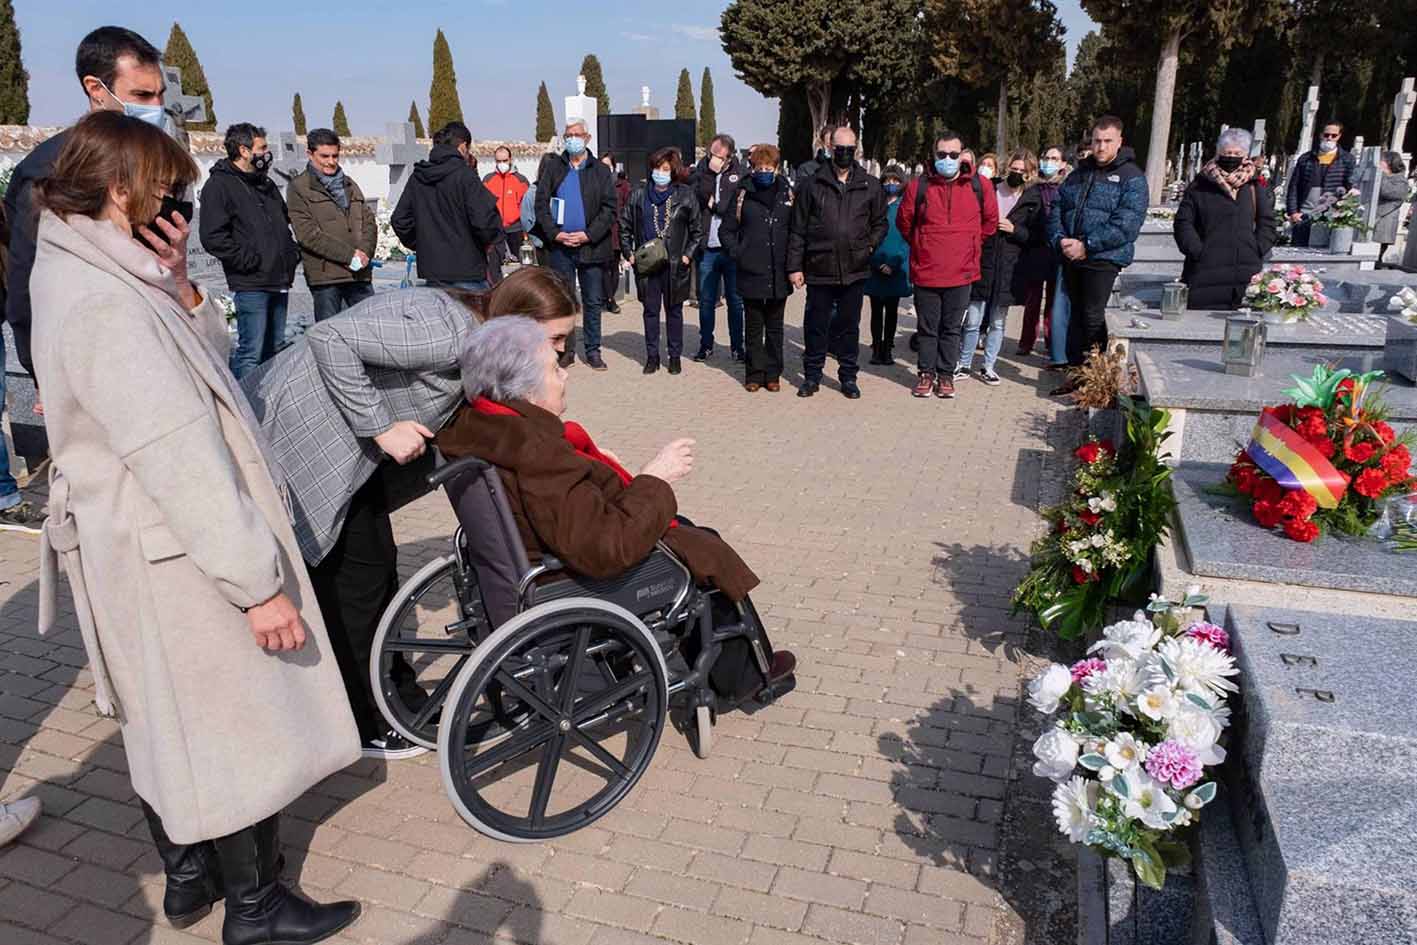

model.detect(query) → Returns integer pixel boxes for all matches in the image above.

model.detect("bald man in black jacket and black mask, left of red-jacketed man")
[788,128,886,400]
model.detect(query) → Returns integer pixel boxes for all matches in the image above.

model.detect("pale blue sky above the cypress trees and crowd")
[14,0,1090,143]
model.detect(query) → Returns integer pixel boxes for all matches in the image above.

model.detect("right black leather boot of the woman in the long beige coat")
[215,815,360,945]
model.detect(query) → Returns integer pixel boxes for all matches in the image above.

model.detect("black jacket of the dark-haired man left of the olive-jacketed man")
[197,157,300,292]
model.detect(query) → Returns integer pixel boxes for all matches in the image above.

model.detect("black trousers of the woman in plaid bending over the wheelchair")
[310,472,399,741]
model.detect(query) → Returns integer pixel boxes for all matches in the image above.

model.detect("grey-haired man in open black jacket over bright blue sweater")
[536,119,618,371]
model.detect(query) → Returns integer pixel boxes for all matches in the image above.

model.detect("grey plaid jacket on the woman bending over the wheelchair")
[241,289,476,565]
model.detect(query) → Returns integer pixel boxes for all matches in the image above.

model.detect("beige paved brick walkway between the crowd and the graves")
[0,296,1076,945]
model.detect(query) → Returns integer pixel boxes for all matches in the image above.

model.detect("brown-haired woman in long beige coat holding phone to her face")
[30,112,360,945]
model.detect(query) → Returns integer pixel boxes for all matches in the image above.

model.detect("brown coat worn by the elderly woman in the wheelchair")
[438,401,758,601]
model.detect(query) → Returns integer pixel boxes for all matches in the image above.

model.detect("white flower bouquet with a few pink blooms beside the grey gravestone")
[1029,592,1238,888]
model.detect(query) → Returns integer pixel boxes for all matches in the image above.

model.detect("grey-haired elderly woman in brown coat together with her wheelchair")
[373,317,796,840]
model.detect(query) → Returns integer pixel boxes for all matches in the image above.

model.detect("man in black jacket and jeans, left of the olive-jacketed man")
[197,122,300,378]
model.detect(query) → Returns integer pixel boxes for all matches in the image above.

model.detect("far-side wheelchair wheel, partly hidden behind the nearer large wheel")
[370,554,487,748]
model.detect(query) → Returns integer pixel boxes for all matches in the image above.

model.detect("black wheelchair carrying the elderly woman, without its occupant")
[370,456,795,843]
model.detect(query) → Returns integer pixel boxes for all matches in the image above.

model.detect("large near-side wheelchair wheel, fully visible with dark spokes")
[438,598,669,843]
